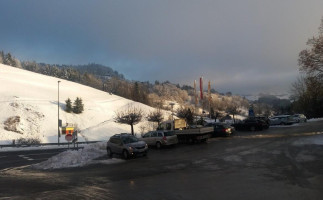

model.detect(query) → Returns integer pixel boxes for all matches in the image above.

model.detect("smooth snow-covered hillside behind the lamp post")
[0,64,158,144]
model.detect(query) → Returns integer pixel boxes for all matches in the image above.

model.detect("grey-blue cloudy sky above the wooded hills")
[0,0,323,94]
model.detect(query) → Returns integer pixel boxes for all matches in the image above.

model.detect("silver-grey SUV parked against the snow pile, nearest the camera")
[107,133,148,159]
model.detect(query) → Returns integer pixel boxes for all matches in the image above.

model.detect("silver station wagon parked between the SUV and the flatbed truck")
[140,131,178,149]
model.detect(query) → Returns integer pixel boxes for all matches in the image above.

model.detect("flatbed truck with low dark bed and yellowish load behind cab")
[157,119,214,143]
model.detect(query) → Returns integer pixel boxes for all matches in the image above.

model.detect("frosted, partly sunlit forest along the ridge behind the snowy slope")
[0,48,296,118]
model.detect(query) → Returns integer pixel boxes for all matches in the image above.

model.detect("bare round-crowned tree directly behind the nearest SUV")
[114,105,144,135]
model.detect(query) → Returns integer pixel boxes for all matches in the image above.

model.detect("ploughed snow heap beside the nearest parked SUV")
[32,142,124,170]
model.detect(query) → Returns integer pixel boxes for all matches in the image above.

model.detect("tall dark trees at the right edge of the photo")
[292,17,323,118]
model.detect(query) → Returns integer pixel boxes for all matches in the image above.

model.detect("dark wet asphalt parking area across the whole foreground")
[0,121,323,200]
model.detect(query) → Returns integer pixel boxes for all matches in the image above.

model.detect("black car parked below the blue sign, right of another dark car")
[232,118,269,131]
